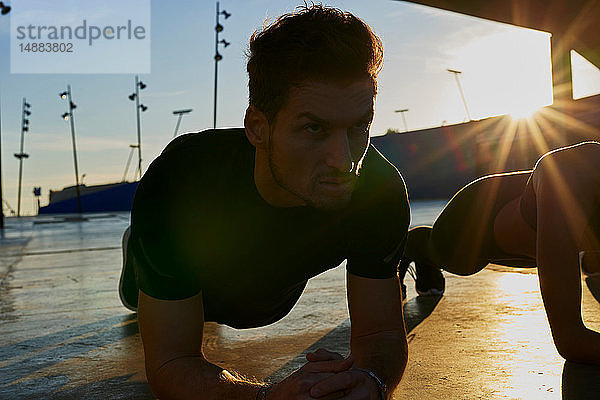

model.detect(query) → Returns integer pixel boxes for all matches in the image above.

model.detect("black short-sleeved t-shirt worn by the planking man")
[129,128,410,328]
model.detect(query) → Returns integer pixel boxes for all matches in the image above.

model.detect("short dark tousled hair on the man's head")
[247,4,383,121]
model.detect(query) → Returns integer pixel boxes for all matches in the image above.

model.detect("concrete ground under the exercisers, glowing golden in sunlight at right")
[0,203,600,399]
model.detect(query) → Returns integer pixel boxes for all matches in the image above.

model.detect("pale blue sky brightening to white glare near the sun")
[0,0,600,215]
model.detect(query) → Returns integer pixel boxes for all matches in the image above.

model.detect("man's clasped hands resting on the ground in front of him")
[267,349,380,400]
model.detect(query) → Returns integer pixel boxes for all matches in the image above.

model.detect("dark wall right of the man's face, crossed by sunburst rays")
[371,95,600,199]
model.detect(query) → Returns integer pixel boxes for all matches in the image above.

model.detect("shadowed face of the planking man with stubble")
[268,79,373,209]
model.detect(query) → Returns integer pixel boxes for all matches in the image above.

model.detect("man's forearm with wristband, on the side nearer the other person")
[350,331,408,398]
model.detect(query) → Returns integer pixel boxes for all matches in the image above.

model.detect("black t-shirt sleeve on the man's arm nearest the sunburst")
[346,146,410,279]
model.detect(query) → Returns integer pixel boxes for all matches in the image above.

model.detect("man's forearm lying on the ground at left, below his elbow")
[146,356,265,400]
